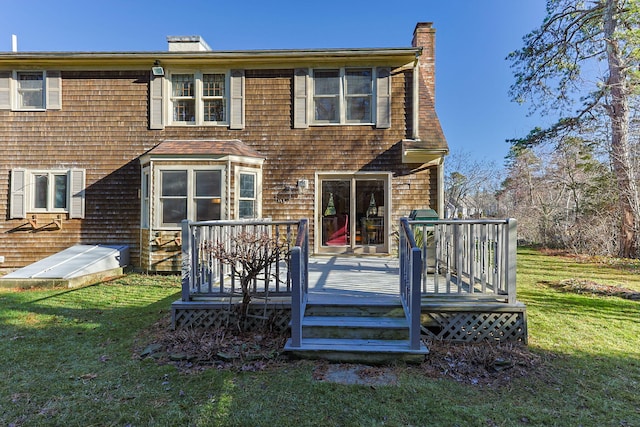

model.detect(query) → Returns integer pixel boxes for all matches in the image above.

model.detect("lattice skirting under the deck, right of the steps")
[422,305,528,344]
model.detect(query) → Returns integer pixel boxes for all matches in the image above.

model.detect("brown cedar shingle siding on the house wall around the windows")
[0,24,446,270]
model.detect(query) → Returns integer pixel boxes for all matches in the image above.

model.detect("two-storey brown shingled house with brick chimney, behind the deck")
[0,23,448,271]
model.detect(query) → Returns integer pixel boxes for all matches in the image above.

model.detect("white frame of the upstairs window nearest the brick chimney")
[309,66,377,126]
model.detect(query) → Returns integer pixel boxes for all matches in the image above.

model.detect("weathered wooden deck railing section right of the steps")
[409,218,517,304]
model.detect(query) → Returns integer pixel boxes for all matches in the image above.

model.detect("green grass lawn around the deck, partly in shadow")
[0,250,640,426]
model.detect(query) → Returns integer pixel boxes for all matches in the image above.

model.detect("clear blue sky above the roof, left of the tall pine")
[0,0,545,166]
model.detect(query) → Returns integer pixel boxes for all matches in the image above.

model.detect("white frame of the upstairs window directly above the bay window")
[166,69,231,126]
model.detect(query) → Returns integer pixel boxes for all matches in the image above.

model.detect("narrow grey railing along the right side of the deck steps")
[399,218,423,350]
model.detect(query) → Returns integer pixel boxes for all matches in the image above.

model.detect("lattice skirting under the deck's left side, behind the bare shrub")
[171,303,291,332]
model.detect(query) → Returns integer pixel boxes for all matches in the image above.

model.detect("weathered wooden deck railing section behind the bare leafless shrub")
[182,220,302,301]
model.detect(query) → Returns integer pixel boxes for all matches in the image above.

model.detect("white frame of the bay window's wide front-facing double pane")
[152,165,226,230]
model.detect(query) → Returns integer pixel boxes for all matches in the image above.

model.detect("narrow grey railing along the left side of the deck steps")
[291,219,309,347]
